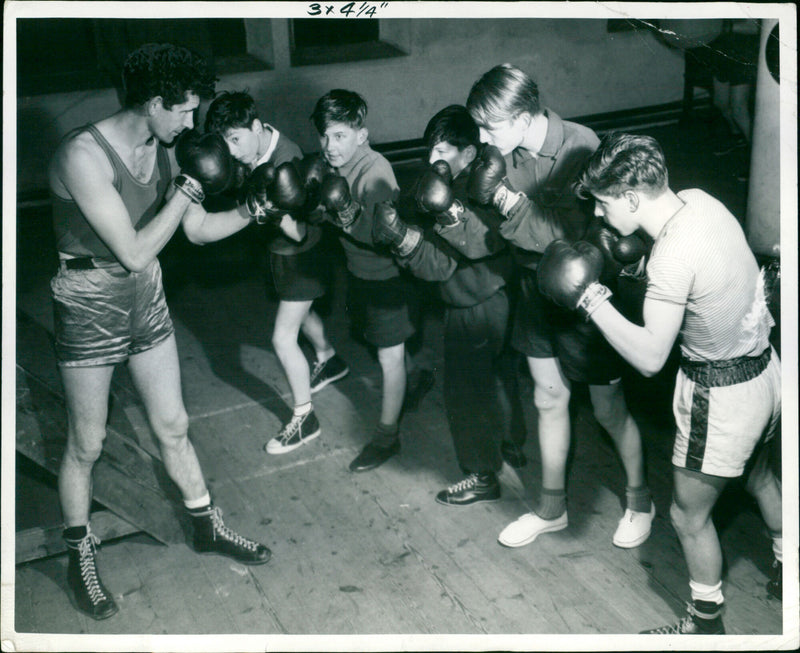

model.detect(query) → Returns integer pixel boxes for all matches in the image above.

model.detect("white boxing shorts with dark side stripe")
[672,349,781,478]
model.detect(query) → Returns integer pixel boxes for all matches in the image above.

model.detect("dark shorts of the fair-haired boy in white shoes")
[511,270,624,385]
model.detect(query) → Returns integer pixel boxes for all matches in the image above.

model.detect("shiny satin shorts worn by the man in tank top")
[50,259,175,367]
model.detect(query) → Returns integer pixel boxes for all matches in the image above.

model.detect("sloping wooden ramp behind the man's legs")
[16,314,183,564]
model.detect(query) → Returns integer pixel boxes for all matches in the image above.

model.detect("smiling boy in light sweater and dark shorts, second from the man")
[311,89,418,472]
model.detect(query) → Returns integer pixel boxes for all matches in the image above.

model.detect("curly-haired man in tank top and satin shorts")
[49,44,270,619]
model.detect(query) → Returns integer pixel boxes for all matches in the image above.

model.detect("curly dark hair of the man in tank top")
[122,43,217,109]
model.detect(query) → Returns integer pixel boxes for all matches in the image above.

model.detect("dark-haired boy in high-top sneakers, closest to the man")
[195,92,349,454]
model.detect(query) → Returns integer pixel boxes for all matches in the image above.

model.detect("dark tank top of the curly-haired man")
[51,125,172,260]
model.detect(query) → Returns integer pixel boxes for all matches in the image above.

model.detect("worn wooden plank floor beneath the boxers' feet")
[9,117,797,650]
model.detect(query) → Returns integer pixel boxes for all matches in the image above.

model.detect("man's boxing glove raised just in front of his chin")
[175,129,234,201]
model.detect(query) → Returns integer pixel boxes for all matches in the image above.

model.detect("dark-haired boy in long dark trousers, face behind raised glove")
[373,105,525,506]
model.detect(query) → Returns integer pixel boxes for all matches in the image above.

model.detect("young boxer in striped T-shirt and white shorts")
[539,134,783,635]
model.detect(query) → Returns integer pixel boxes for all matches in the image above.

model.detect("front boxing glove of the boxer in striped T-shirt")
[536,239,611,320]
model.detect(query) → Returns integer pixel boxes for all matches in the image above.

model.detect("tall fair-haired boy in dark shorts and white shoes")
[441,64,655,548]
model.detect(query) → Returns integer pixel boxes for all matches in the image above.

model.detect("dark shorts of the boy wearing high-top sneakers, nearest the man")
[269,243,331,302]
